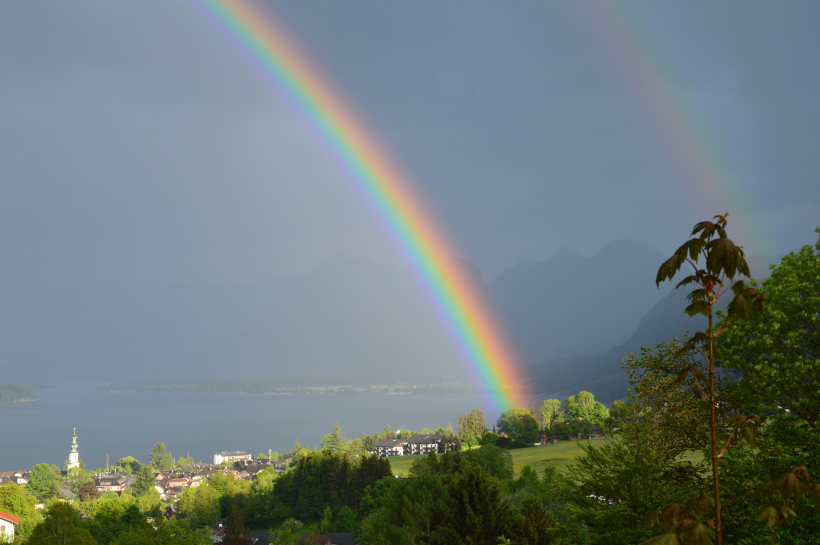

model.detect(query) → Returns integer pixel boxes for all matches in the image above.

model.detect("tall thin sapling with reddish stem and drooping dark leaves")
[655,213,766,545]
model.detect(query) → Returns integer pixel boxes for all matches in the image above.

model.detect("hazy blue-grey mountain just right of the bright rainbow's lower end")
[487,240,670,364]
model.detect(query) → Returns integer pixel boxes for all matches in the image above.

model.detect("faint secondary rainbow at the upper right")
[573,1,776,254]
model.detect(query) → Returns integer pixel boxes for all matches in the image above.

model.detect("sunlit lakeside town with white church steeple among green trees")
[0,392,617,545]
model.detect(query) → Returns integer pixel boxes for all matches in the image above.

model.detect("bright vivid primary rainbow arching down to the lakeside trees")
[186,0,524,412]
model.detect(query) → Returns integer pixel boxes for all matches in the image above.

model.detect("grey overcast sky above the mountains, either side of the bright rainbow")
[0,0,820,285]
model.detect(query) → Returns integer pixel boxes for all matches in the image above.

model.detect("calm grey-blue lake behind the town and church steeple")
[0,383,552,471]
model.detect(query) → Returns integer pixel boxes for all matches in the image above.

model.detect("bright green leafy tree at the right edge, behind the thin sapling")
[719,228,820,432]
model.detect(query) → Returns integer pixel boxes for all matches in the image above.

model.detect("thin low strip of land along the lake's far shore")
[98,377,484,395]
